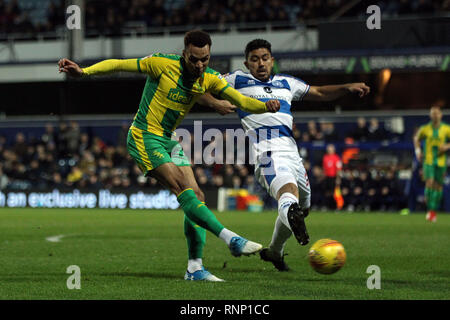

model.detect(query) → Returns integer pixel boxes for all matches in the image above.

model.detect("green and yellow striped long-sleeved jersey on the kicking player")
[83,53,267,137]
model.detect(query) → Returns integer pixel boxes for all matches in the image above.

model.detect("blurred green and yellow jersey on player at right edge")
[417,122,450,167]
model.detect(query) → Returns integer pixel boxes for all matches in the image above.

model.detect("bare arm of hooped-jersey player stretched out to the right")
[303,82,370,101]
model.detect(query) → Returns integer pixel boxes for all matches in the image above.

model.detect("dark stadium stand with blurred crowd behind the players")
[0,0,450,211]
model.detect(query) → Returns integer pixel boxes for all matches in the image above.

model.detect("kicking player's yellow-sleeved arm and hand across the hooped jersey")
[220,87,280,113]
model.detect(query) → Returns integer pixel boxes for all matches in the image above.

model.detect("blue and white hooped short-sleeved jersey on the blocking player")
[225,70,309,160]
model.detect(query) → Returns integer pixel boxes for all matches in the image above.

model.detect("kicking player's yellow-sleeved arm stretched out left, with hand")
[58,58,140,77]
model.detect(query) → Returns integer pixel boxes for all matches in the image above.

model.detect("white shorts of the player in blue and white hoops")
[255,151,311,208]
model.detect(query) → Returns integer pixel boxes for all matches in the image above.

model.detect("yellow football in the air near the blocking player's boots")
[308,239,347,274]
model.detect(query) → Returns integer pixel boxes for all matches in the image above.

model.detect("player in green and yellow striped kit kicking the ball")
[58,30,280,281]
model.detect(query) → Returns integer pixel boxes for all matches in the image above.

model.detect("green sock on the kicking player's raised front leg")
[177,188,224,236]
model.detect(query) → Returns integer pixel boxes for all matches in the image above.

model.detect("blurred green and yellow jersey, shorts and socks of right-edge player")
[417,122,450,210]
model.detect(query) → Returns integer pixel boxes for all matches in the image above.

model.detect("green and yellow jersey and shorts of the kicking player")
[83,53,267,175]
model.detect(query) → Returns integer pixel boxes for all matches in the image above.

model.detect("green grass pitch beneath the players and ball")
[0,209,450,300]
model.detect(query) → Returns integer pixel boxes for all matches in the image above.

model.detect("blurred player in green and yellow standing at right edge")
[413,106,450,222]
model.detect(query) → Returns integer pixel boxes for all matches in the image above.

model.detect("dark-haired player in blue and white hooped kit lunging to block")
[199,39,370,271]
